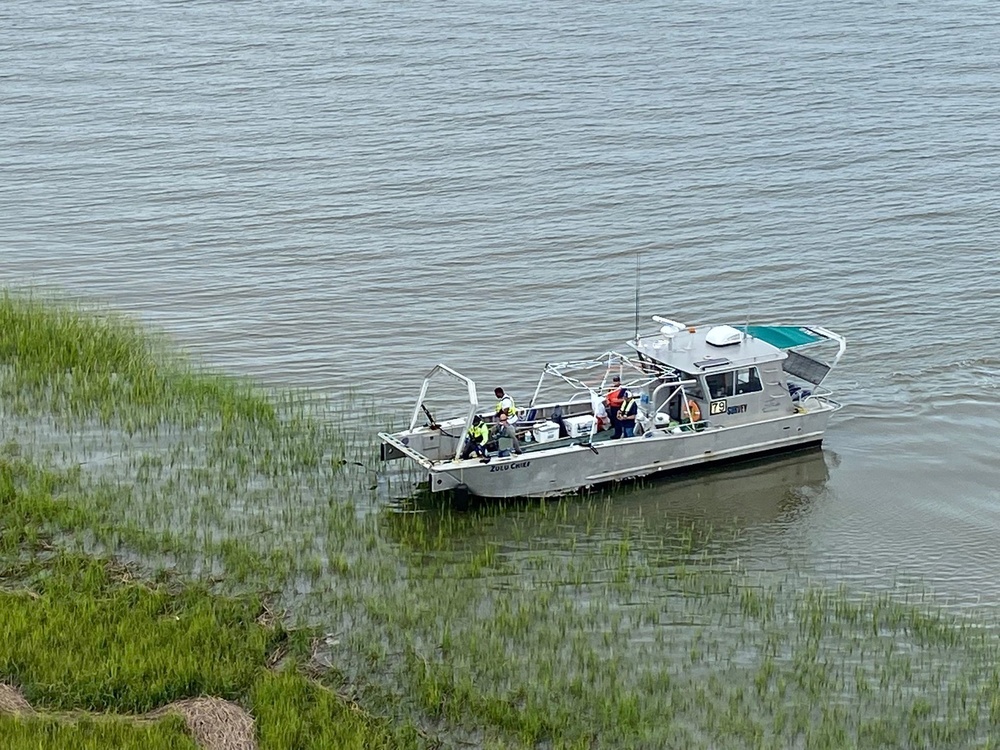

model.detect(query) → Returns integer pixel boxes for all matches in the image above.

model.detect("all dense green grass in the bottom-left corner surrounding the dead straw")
[0,555,419,750]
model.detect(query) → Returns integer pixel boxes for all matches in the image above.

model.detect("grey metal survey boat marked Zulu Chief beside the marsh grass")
[378,315,846,498]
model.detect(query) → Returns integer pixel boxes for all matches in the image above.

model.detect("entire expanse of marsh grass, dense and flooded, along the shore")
[0,295,1000,749]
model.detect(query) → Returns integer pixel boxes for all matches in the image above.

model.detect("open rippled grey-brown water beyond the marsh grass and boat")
[0,0,1000,608]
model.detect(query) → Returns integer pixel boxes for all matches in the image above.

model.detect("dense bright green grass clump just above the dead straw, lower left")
[0,556,287,714]
